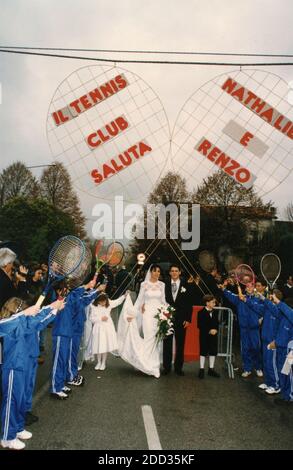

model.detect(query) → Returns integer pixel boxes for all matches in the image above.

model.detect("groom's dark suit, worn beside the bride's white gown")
[163,280,192,372]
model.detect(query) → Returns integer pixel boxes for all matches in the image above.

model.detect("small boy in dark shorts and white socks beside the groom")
[197,295,220,379]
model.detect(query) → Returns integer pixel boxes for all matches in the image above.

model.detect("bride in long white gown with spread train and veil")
[118,264,166,378]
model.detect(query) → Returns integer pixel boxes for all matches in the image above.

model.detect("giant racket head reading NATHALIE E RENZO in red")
[172,70,293,195]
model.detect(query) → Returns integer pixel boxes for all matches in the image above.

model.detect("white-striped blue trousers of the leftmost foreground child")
[1,367,26,441]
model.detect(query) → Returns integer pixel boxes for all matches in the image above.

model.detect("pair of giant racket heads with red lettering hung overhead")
[47,66,293,201]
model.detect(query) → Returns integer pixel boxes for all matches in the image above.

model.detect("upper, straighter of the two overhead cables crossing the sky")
[0,46,293,58]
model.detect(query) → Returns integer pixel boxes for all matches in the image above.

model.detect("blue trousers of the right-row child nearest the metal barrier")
[240,327,262,372]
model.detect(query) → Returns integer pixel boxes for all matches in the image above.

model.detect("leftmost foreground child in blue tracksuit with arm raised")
[0,298,63,450]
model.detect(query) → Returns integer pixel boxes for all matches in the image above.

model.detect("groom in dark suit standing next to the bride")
[162,264,192,375]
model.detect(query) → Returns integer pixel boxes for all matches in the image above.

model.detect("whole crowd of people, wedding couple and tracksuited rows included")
[0,244,293,449]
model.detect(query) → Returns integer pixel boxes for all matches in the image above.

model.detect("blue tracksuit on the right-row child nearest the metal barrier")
[223,290,262,372]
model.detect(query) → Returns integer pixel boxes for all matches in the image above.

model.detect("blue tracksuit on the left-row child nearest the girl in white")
[67,287,98,382]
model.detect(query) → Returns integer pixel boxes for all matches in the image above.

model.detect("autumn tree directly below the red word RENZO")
[192,170,276,252]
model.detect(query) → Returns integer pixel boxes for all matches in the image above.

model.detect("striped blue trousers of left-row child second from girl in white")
[51,336,71,393]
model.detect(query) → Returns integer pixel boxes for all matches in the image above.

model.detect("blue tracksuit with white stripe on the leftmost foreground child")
[0,309,55,441]
